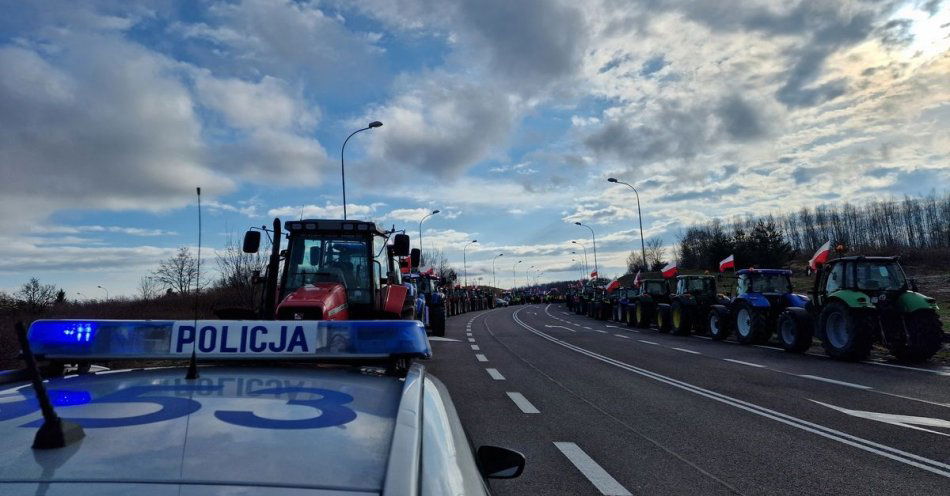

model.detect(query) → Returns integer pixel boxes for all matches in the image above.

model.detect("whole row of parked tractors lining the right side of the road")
[566,256,945,363]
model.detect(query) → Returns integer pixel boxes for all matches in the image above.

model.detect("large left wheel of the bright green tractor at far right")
[818,302,874,361]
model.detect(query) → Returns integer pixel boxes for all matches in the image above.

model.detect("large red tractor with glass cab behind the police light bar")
[243,219,415,320]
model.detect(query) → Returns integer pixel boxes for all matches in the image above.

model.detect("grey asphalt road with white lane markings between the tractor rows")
[427,305,950,495]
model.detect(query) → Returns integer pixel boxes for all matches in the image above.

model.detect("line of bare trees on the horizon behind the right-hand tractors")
[674,192,950,270]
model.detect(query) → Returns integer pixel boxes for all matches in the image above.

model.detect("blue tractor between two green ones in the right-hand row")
[709,269,808,344]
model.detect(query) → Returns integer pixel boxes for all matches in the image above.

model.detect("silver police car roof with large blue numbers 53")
[0,367,402,494]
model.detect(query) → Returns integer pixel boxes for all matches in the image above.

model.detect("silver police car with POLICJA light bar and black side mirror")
[0,320,524,496]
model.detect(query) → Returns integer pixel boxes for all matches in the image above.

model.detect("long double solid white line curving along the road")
[511,311,950,478]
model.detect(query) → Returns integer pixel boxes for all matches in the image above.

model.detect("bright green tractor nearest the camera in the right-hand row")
[778,256,943,363]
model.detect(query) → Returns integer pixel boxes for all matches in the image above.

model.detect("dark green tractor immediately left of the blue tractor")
[656,275,728,336]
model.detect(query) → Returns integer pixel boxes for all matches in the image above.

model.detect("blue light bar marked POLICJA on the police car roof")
[29,320,432,361]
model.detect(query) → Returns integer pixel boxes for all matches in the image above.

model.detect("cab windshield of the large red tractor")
[285,234,373,304]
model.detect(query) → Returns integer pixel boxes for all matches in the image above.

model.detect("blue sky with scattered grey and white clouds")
[0,0,950,297]
